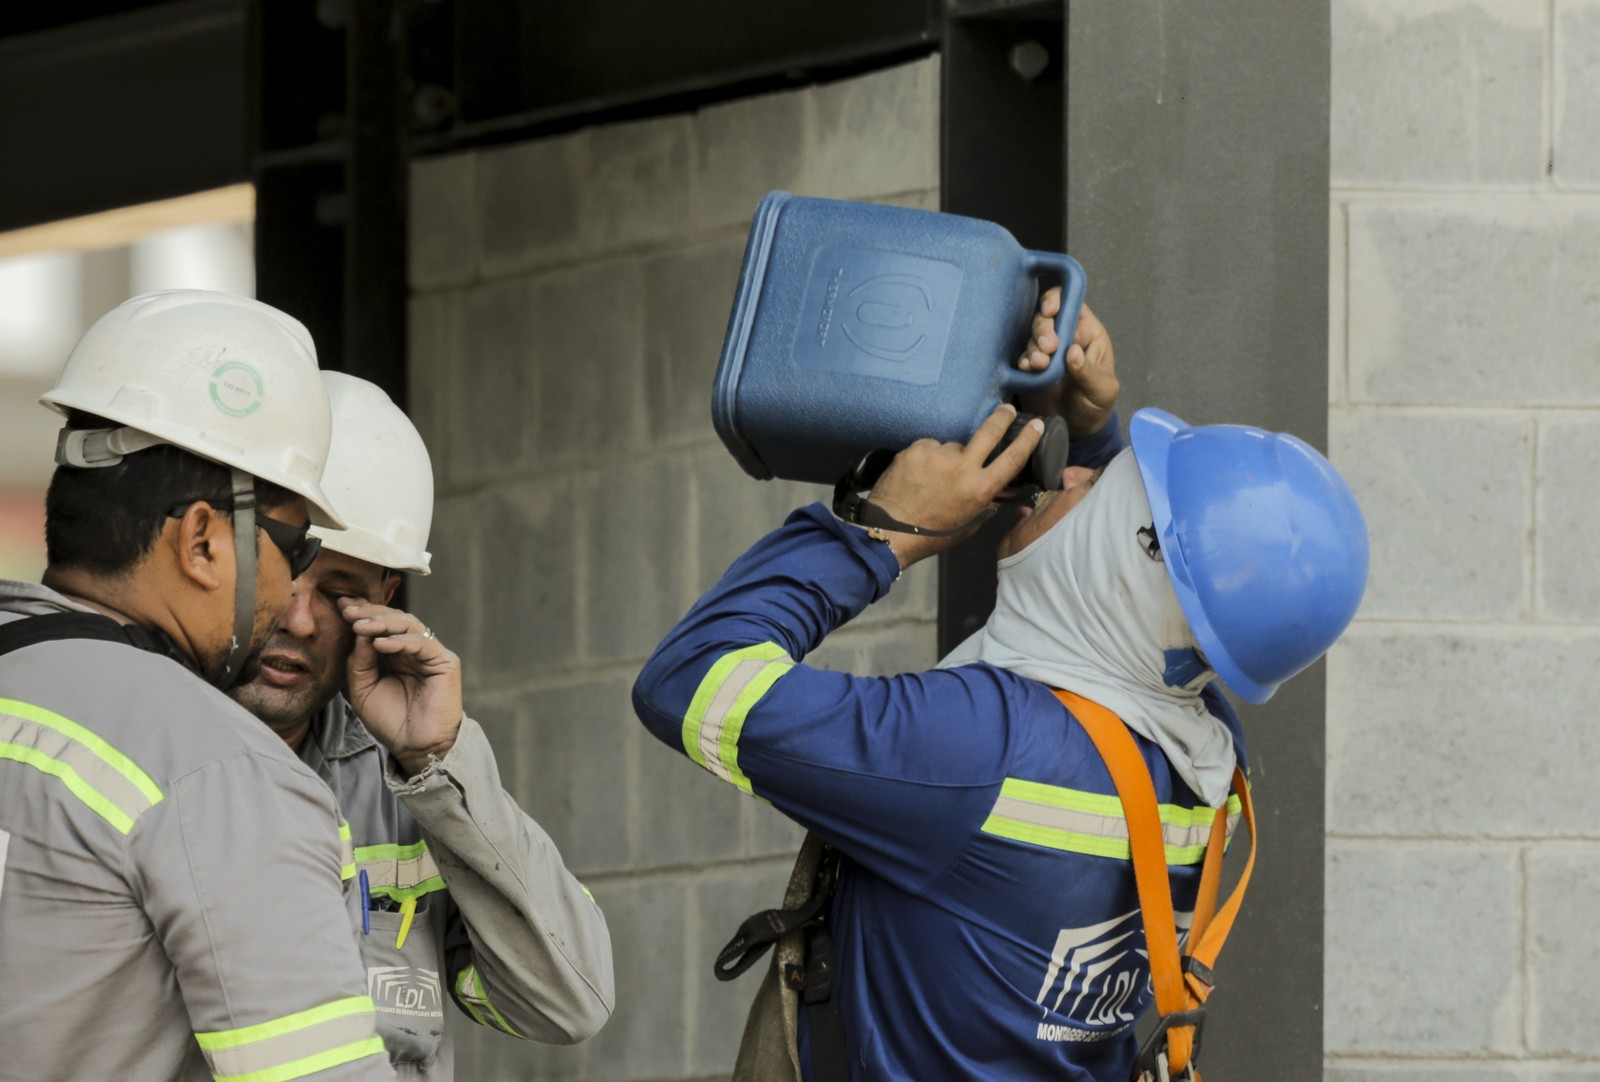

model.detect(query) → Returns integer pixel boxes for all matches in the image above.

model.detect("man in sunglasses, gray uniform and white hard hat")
[0,290,394,1082]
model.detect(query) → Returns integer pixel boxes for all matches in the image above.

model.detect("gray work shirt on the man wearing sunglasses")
[0,579,395,1082]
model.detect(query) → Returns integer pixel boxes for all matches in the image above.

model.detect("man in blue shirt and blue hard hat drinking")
[634,297,1366,1082]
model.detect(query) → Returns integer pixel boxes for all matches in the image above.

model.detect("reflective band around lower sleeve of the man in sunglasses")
[195,996,384,1082]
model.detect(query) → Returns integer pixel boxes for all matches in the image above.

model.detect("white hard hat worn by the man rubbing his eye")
[312,371,434,575]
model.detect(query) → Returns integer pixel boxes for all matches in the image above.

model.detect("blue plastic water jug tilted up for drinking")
[712,192,1083,483]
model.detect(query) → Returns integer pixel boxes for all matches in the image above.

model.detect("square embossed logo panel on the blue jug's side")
[794,246,962,384]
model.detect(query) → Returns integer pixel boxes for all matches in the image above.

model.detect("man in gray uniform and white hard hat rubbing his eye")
[232,371,614,1079]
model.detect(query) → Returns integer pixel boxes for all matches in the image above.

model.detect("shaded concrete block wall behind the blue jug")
[410,59,939,1082]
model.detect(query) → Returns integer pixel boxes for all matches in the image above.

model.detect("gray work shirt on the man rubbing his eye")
[301,695,616,1082]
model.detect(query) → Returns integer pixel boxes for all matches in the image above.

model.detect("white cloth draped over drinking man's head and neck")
[939,450,1234,808]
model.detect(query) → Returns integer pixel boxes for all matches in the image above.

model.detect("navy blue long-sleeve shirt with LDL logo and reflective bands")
[634,419,1240,1082]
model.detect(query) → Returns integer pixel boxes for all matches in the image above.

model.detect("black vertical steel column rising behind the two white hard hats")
[251,0,411,407]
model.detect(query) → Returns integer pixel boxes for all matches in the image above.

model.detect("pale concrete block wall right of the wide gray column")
[1325,0,1600,1082]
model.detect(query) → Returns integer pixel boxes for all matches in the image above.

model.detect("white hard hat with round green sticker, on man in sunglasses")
[40,290,342,530]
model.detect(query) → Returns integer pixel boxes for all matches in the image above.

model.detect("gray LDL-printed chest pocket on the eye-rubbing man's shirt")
[355,898,445,1066]
